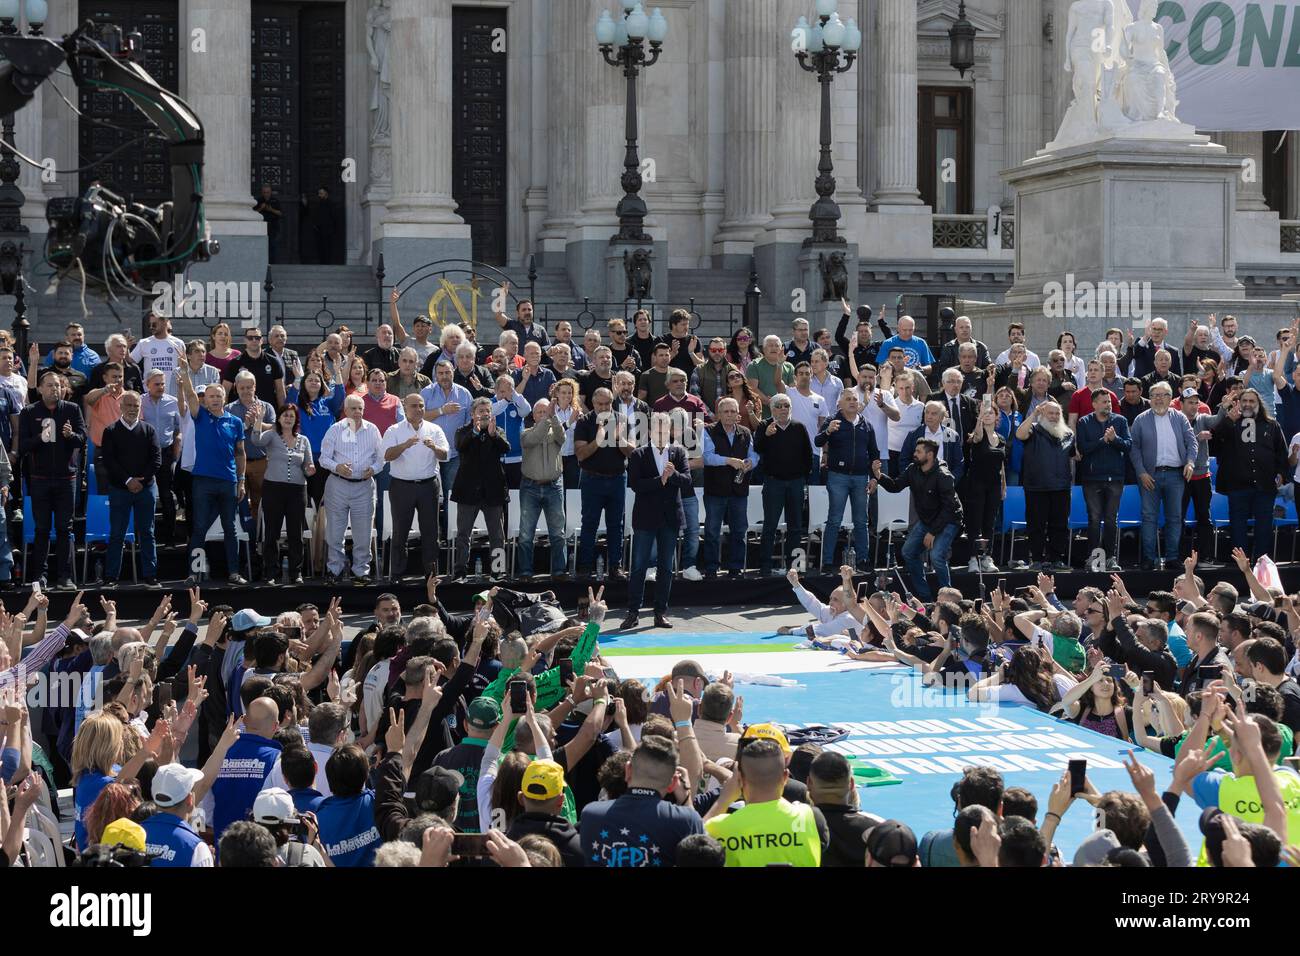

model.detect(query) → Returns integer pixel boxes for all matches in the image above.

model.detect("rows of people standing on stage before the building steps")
[0,299,1300,622]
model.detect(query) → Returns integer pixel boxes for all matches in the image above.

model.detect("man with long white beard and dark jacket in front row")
[1015,398,1074,572]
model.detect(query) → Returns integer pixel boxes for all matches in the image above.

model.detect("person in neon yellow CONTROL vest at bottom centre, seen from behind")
[705,739,828,866]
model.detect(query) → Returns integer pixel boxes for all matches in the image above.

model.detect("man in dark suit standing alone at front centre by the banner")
[620,412,690,631]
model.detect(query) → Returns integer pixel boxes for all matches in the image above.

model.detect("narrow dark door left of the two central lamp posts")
[449,7,507,265]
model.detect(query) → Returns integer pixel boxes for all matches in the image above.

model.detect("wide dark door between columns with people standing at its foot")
[250,3,346,263]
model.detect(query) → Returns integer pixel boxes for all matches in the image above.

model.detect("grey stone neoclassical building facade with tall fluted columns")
[16,0,1300,338]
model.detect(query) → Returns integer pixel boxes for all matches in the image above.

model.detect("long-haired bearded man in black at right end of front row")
[1214,389,1287,561]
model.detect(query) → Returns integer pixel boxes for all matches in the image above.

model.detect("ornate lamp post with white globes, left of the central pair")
[595,0,668,242]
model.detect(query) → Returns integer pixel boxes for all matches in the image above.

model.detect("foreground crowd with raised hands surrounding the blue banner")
[0,553,1300,868]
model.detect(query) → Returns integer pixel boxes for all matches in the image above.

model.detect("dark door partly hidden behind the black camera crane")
[77,0,180,206]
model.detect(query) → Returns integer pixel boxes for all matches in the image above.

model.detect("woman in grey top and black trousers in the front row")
[252,405,316,584]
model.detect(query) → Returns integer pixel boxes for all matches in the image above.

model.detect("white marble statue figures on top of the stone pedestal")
[1043,0,1204,152]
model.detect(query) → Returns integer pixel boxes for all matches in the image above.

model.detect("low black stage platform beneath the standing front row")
[17,564,1300,626]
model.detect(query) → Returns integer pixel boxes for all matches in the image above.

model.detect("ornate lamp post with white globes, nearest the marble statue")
[790,0,862,246]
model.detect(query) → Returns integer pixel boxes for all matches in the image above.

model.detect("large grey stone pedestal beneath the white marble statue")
[1002,137,1245,346]
